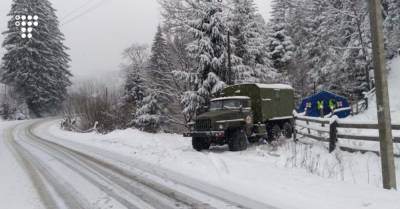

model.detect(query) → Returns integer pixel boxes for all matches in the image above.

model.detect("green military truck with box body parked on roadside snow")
[184,84,295,151]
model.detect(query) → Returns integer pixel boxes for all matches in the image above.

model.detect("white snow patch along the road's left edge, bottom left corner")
[0,121,45,209]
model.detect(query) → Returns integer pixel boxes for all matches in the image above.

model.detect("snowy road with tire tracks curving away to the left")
[4,120,275,209]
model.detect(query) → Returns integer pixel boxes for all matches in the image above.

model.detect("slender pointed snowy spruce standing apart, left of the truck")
[136,26,175,132]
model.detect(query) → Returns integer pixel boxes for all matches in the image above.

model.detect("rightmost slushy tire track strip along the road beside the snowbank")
[35,120,279,209]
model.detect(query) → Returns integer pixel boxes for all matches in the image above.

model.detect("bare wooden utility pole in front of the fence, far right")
[369,0,397,189]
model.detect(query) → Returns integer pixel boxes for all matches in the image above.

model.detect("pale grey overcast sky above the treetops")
[0,0,271,77]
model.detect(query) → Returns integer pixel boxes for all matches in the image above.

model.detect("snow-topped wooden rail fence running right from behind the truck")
[293,116,400,157]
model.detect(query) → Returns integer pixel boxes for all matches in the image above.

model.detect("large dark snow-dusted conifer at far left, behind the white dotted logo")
[1,0,71,116]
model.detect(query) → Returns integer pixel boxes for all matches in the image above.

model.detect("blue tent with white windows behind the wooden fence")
[297,91,351,118]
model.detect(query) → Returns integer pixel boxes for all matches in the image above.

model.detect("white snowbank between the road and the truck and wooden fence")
[35,119,400,209]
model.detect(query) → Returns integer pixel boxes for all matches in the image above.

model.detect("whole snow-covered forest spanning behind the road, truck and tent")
[0,0,400,133]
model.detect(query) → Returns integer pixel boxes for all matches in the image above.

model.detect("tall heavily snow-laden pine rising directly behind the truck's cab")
[161,0,228,121]
